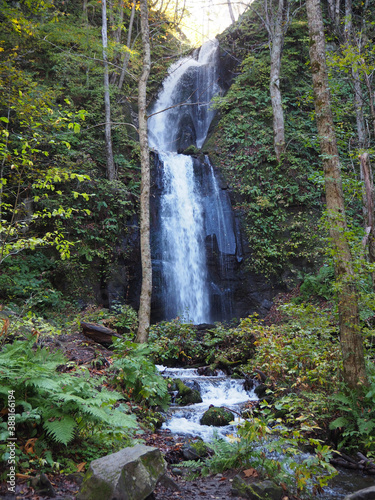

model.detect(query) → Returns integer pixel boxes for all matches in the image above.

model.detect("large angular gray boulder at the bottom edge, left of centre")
[77,444,166,500]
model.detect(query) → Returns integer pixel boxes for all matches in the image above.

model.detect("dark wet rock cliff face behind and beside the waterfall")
[100,39,282,322]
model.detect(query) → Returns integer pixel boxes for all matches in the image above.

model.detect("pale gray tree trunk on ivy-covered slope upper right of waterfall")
[270,0,285,161]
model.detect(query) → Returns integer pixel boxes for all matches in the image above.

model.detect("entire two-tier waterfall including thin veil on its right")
[149,40,236,324]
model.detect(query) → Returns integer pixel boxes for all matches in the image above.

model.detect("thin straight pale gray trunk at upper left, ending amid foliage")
[102,0,116,181]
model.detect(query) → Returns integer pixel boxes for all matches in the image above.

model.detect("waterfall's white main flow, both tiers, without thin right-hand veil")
[149,40,219,324]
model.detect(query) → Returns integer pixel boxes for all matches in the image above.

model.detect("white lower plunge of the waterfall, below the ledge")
[160,153,209,323]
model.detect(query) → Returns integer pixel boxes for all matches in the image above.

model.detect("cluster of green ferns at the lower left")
[0,338,138,445]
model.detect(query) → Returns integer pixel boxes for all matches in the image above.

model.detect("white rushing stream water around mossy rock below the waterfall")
[158,366,258,442]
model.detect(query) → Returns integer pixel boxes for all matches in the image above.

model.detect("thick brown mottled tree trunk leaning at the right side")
[306,0,368,389]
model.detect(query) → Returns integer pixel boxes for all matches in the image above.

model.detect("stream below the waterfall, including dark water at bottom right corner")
[157,366,375,500]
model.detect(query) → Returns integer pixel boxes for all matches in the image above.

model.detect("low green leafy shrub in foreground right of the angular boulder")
[182,413,337,498]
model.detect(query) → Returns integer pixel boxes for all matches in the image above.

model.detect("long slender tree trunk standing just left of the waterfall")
[136,0,152,342]
